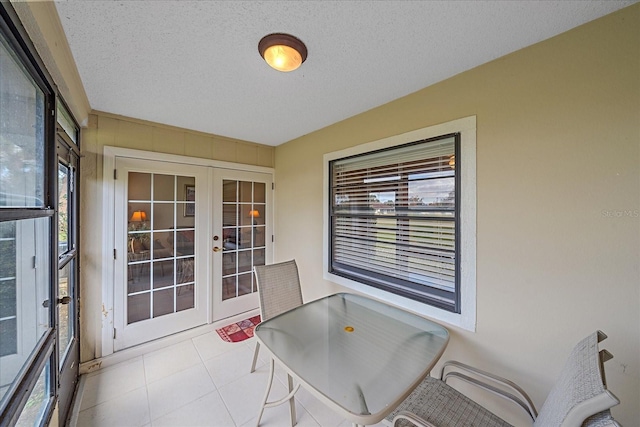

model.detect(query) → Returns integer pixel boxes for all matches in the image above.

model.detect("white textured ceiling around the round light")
[56,0,637,145]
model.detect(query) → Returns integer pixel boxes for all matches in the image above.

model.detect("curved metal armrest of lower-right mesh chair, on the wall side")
[440,360,538,421]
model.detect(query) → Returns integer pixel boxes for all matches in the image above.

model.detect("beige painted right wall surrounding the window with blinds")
[275,4,640,426]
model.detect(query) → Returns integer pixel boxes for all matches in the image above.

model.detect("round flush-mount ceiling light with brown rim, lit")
[258,33,307,72]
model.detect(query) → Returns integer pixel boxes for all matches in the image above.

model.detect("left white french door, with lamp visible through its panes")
[114,157,210,351]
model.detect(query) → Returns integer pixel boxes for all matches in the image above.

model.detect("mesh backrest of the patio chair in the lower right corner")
[534,331,620,427]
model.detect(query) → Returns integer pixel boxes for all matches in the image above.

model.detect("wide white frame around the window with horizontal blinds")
[323,116,476,332]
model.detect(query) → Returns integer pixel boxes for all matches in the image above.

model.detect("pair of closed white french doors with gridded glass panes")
[103,152,273,355]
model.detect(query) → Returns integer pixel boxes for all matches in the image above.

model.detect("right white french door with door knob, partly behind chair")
[212,168,273,321]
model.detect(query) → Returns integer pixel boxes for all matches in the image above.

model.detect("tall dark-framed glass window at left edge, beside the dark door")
[0,6,66,425]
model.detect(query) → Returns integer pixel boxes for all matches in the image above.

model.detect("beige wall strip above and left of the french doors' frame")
[80,112,275,362]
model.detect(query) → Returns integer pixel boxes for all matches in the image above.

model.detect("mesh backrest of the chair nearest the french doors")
[253,260,302,320]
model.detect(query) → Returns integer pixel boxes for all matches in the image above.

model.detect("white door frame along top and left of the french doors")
[100,146,275,358]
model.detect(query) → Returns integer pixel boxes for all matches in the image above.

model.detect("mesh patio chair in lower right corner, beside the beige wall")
[387,331,620,427]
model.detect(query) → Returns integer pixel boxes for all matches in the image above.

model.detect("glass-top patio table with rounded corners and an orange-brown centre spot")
[255,293,449,425]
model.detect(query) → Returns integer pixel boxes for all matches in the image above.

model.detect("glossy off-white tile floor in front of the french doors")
[71,331,385,427]
